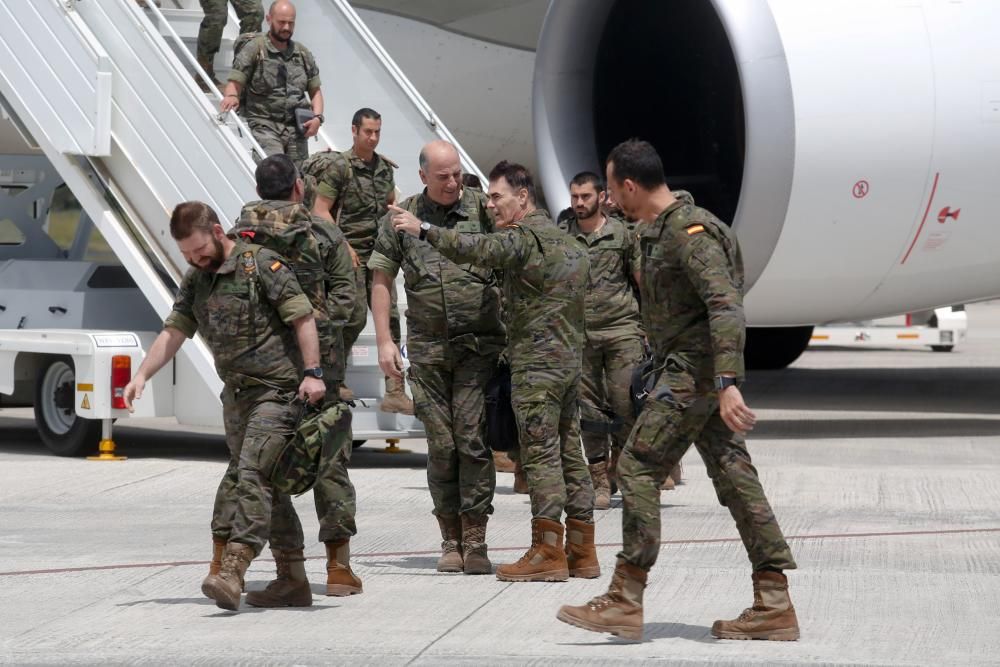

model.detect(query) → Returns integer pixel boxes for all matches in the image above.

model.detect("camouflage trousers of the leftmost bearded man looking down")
[212,386,303,554]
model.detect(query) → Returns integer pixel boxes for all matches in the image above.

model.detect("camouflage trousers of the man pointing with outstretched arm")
[511,366,594,523]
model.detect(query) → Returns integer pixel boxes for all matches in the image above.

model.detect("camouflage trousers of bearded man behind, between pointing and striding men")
[580,336,642,462]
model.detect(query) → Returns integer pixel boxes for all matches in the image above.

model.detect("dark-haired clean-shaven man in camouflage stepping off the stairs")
[302,107,413,415]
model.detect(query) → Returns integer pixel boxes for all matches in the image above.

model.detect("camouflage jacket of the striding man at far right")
[639,193,746,390]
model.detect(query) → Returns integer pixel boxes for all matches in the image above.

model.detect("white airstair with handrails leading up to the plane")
[0,0,479,452]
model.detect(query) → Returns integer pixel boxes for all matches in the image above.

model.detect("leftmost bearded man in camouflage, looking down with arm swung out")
[125,202,325,609]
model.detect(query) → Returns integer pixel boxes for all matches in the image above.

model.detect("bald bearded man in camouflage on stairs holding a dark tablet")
[220,0,323,164]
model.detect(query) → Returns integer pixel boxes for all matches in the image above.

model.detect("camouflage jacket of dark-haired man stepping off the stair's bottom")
[302,148,399,261]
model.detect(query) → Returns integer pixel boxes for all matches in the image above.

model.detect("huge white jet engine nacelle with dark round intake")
[533,0,1000,326]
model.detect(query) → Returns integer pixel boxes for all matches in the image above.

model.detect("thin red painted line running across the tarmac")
[0,528,1000,577]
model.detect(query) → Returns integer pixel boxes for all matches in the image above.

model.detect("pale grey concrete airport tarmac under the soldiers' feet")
[0,302,1000,665]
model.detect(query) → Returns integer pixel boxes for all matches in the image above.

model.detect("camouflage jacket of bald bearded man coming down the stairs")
[229,33,320,126]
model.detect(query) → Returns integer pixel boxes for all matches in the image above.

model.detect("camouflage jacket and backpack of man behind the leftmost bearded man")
[232,200,356,383]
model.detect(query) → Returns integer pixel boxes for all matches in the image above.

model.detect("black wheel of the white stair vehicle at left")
[35,357,101,456]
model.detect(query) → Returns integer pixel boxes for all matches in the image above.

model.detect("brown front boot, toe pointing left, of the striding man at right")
[556,559,646,640]
